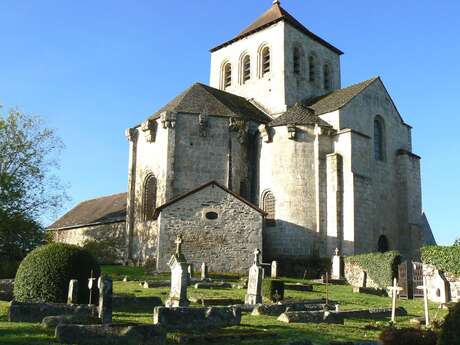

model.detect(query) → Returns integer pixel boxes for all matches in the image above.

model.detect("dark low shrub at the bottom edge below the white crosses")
[379,327,436,345]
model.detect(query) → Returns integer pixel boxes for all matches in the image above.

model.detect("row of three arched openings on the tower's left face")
[221,46,271,90]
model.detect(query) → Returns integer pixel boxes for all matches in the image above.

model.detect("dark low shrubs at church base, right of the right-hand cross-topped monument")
[268,255,332,279]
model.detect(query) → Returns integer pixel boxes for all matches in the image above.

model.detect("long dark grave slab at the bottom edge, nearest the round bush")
[55,324,166,345]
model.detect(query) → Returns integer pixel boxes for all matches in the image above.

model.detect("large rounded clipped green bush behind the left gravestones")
[14,243,101,303]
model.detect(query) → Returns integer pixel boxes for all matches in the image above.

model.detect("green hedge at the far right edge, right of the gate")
[421,246,460,277]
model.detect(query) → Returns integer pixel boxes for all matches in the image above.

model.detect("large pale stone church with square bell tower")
[49,1,434,272]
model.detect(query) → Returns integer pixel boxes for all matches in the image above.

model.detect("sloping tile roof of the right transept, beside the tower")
[303,77,379,115]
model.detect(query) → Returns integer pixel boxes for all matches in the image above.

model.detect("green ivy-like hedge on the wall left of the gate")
[345,251,401,289]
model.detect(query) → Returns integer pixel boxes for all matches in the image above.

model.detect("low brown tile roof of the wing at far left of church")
[48,193,127,230]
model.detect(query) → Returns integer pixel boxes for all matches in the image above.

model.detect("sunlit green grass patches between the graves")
[0,266,446,345]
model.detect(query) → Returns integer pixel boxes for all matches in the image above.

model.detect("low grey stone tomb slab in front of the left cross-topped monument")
[153,307,241,331]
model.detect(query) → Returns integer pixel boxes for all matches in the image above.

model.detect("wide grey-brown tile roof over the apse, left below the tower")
[151,83,271,123]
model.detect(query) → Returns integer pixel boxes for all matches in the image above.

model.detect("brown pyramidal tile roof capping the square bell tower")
[211,2,343,55]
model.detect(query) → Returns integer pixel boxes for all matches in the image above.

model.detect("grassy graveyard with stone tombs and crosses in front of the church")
[0,238,447,345]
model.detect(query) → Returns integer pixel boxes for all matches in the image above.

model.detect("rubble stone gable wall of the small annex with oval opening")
[158,185,263,273]
